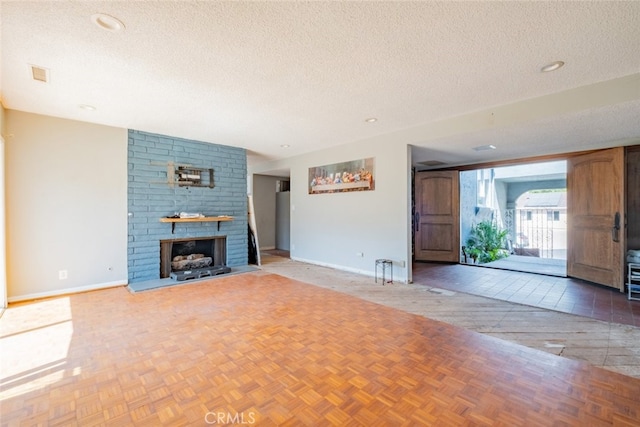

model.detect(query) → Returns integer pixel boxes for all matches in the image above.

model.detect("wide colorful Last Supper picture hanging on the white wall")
[309,157,375,194]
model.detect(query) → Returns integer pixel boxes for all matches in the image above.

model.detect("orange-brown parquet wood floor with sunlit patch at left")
[0,271,640,426]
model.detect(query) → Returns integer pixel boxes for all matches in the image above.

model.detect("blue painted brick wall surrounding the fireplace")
[128,130,248,283]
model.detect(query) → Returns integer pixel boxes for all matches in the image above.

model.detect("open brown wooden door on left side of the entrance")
[414,171,460,262]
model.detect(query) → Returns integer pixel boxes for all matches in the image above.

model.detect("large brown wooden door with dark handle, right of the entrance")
[567,147,625,291]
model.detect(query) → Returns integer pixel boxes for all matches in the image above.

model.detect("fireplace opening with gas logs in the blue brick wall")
[160,236,231,281]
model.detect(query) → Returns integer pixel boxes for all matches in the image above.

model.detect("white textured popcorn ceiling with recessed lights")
[0,1,640,172]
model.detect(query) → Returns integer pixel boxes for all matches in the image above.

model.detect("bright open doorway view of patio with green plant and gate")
[460,160,567,277]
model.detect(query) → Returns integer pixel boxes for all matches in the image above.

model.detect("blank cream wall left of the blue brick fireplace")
[5,110,127,301]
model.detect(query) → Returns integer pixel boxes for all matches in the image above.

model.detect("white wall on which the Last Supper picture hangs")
[249,136,411,281]
